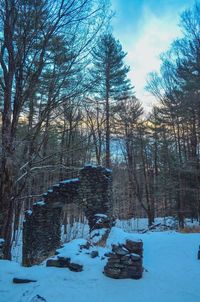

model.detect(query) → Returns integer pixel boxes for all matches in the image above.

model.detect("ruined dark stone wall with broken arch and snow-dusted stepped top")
[22,166,112,266]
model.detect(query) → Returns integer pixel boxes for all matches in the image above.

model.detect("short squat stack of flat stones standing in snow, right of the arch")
[104,240,143,279]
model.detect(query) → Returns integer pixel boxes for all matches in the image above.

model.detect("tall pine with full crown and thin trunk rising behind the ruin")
[91,33,132,168]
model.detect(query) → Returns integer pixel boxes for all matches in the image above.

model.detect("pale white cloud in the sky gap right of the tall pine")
[126,7,183,109]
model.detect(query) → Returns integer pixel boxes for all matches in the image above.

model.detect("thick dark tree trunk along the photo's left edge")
[0,1,15,259]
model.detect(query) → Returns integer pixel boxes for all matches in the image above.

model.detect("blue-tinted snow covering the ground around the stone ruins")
[0,227,200,302]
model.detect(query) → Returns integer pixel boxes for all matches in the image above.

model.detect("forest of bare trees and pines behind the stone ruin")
[0,0,200,259]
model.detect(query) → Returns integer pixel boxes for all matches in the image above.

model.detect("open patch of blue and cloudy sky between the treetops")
[111,0,195,111]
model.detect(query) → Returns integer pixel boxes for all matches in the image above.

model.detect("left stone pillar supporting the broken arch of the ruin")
[22,201,62,266]
